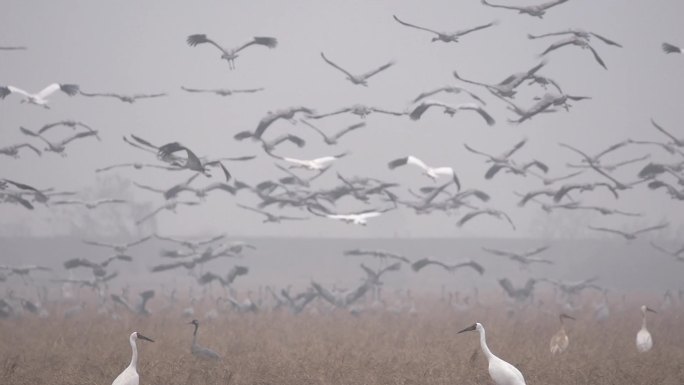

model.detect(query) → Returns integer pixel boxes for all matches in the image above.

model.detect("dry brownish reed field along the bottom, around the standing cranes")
[0,300,684,385]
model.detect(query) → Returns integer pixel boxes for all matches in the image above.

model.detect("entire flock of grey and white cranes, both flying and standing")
[0,0,684,385]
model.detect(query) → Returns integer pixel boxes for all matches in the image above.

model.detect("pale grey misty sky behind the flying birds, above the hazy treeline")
[0,0,684,237]
